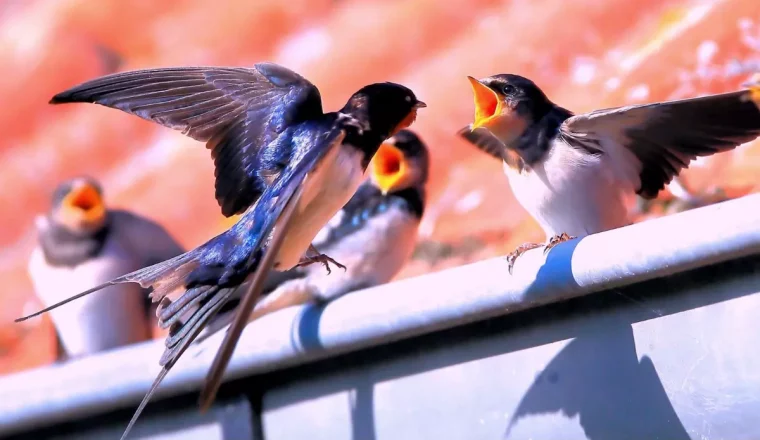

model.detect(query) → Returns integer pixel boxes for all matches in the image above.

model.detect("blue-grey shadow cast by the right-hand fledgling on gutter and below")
[505,240,758,440]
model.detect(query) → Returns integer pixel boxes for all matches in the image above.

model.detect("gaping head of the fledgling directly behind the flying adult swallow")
[370,130,429,194]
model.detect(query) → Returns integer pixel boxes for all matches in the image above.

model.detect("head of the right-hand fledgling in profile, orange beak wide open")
[467,73,553,147]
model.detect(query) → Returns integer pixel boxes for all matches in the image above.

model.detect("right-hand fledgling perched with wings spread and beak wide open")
[459,74,760,273]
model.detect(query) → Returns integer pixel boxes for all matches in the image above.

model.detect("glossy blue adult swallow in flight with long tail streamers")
[20,63,425,438]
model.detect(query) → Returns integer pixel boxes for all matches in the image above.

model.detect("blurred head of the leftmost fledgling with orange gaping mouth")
[51,177,107,233]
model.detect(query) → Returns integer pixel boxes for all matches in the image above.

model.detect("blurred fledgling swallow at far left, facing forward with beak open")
[28,177,184,358]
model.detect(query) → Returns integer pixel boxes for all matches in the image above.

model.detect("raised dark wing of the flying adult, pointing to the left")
[50,63,322,217]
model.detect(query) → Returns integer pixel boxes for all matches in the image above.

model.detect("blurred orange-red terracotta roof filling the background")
[0,0,760,373]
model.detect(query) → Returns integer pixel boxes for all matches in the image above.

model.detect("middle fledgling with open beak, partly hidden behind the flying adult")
[203,130,429,338]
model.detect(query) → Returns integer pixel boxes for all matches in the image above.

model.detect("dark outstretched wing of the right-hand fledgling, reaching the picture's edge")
[560,90,760,198]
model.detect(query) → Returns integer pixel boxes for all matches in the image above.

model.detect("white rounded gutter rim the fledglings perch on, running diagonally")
[0,195,760,435]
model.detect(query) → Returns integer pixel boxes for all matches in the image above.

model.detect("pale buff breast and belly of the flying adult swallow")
[275,144,364,270]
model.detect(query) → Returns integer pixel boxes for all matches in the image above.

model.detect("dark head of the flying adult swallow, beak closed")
[342,82,427,139]
